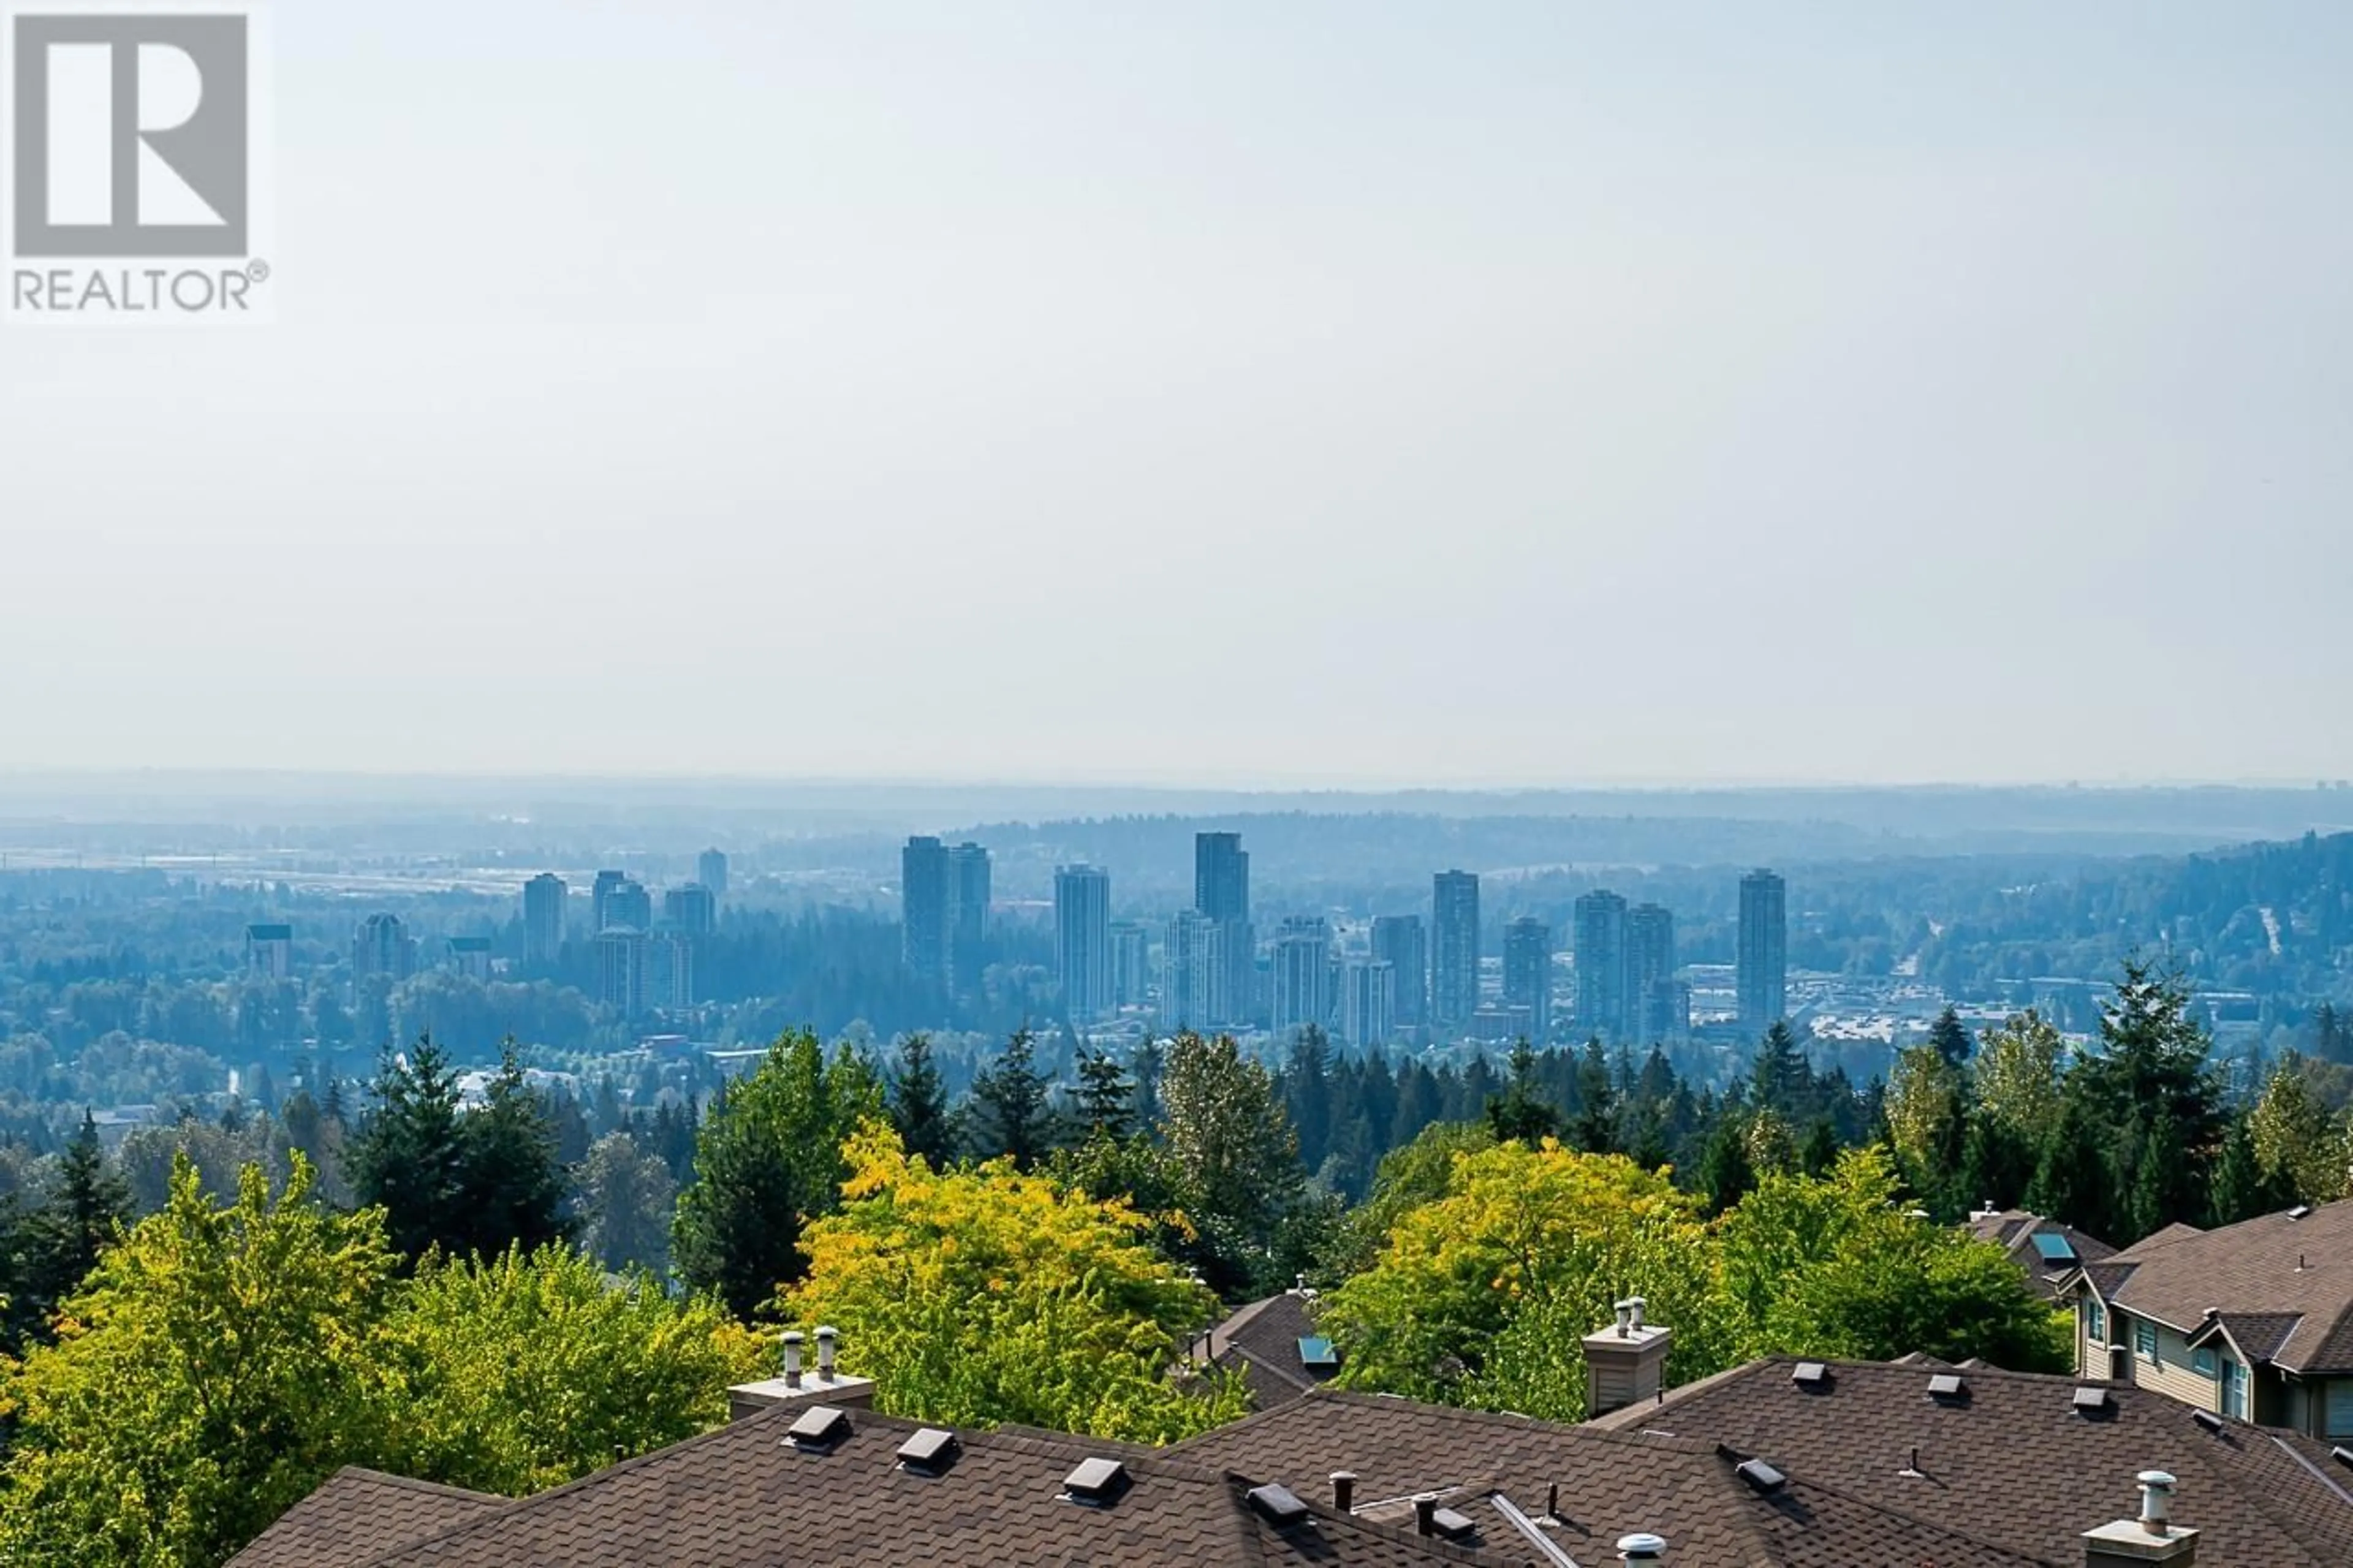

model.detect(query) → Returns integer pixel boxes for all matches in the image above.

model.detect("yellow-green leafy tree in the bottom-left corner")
[0,1156,393,1568]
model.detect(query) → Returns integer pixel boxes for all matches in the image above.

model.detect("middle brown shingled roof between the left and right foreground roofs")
[1169,1389,2061,1568]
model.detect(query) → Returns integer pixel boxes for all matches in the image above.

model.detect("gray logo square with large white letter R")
[9,14,252,259]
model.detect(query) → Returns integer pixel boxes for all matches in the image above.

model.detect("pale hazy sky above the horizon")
[0,0,2353,784]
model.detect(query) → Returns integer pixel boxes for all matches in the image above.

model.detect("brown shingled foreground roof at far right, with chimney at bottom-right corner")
[1597,1356,2353,1568]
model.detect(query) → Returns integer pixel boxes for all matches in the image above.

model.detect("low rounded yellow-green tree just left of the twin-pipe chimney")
[374,1246,770,1498]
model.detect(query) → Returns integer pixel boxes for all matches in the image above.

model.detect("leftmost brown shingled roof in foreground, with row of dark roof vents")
[224,1406,1525,1568]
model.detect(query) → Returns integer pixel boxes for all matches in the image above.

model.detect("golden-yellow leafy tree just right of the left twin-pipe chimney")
[784,1123,1247,1443]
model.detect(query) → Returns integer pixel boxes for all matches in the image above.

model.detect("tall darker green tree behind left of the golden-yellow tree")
[670,1031,882,1321]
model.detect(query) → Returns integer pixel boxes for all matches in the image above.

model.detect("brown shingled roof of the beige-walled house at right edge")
[2085,1201,2353,1377]
